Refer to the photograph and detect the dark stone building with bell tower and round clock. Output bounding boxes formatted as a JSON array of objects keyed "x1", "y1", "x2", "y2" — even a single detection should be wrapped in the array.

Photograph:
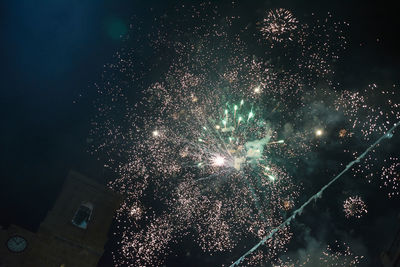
[{"x1": 0, "y1": 171, "x2": 121, "y2": 267}]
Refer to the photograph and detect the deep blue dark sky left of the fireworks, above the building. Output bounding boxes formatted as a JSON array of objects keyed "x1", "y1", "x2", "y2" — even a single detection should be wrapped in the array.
[{"x1": 0, "y1": 0, "x2": 156, "y2": 227}]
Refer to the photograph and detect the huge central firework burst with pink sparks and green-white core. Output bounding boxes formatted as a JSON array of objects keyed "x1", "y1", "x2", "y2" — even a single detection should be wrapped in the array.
[{"x1": 92, "y1": 4, "x2": 398, "y2": 266}]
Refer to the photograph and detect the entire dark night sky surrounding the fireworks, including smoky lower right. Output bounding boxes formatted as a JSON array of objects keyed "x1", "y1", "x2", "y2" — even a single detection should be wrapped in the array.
[{"x1": 0, "y1": 0, "x2": 400, "y2": 266}]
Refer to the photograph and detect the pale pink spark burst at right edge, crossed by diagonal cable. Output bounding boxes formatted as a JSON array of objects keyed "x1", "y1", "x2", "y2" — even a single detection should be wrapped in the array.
[{"x1": 335, "y1": 84, "x2": 400, "y2": 198}]
